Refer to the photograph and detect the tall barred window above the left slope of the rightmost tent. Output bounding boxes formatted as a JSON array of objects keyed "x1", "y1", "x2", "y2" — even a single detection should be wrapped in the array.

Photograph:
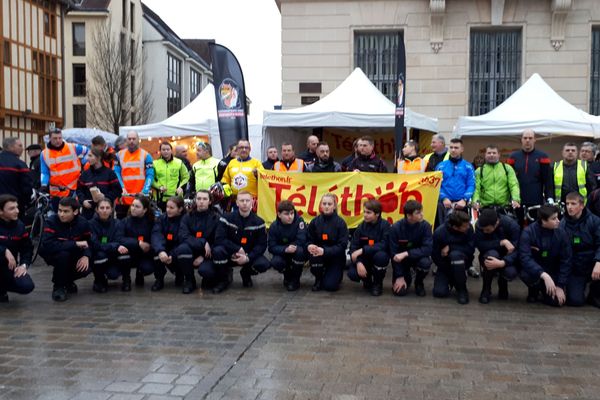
[{"x1": 469, "y1": 30, "x2": 521, "y2": 115}]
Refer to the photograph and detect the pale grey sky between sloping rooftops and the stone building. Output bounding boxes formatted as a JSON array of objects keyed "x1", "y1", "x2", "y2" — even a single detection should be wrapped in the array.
[{"x1": 144, "y1": 0, "x2": 281, "y2": 121}]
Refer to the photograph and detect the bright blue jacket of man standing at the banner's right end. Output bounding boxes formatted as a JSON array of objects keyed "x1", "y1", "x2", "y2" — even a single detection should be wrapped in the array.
[{"x1": 435, "y1": 158, "x2": 475, "y2": 201}]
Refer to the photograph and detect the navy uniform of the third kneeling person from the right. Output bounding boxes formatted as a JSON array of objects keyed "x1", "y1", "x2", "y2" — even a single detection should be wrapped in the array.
[{"x1": 475, "y1": 215, "x2": 521, "y2": 302}]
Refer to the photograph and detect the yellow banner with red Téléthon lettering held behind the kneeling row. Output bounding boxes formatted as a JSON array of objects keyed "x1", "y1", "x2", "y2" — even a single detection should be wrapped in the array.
[{"x1": 258, "y1": 171, "x2": 442, "y2": 228}]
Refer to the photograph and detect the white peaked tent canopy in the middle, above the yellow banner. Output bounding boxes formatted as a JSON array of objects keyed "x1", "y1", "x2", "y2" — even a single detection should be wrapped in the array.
[{"x1": 263, "y1": 68, "x2": 438, "y2": 151}]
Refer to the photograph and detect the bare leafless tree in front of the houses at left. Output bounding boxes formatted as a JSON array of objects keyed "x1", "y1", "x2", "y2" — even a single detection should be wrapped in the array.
[{"x1": 87, "y1": 20, "x2": 153, "y2": 134}]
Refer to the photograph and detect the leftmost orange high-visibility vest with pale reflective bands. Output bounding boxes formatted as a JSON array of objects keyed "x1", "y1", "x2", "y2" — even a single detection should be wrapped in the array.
[{"x1": 44, "y1": 143, "x2": 81, "y2": 197}]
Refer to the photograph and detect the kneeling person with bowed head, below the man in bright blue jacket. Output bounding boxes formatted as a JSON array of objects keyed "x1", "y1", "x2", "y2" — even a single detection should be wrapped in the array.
[{"x1": 431, "y1": 211, "x2": 475, "y2": 304}]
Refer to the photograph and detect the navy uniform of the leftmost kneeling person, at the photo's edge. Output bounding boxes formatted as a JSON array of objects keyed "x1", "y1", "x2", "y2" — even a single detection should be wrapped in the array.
[{"x1": 0, "y1": 219, "x2": 35, "y2": 300}]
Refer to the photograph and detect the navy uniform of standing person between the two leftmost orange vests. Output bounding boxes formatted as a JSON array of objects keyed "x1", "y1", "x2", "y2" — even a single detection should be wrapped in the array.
[{"x1": 77, "y1": 165, "x2": 123, "y2": 219}]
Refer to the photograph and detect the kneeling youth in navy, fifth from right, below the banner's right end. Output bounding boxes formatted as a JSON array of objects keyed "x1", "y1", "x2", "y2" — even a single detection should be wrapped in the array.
[{"x1": 389, "y1": 200, "x2": 433, "y2": 297}]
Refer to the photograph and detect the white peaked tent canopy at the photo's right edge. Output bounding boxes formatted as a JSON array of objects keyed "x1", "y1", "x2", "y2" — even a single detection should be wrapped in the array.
[{"x1": 454, "y1": 73, "x2": 600, "y2": 138}]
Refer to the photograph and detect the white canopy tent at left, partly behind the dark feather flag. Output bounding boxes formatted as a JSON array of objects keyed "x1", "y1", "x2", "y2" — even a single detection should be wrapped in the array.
[{"x1": 119, "y1": 83, "x2": 262, "y2": 159}]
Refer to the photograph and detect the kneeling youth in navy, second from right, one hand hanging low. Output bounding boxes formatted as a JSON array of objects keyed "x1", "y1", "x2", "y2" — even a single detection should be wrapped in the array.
[{"x1": 519, "y1": 204, "x2": 572, "y2": 306}]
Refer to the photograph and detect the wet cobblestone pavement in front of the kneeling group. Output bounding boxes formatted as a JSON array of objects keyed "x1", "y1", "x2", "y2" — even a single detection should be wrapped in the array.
[{"x1": 0, "y1": 266, "x2": 600, "y2": 400}]
